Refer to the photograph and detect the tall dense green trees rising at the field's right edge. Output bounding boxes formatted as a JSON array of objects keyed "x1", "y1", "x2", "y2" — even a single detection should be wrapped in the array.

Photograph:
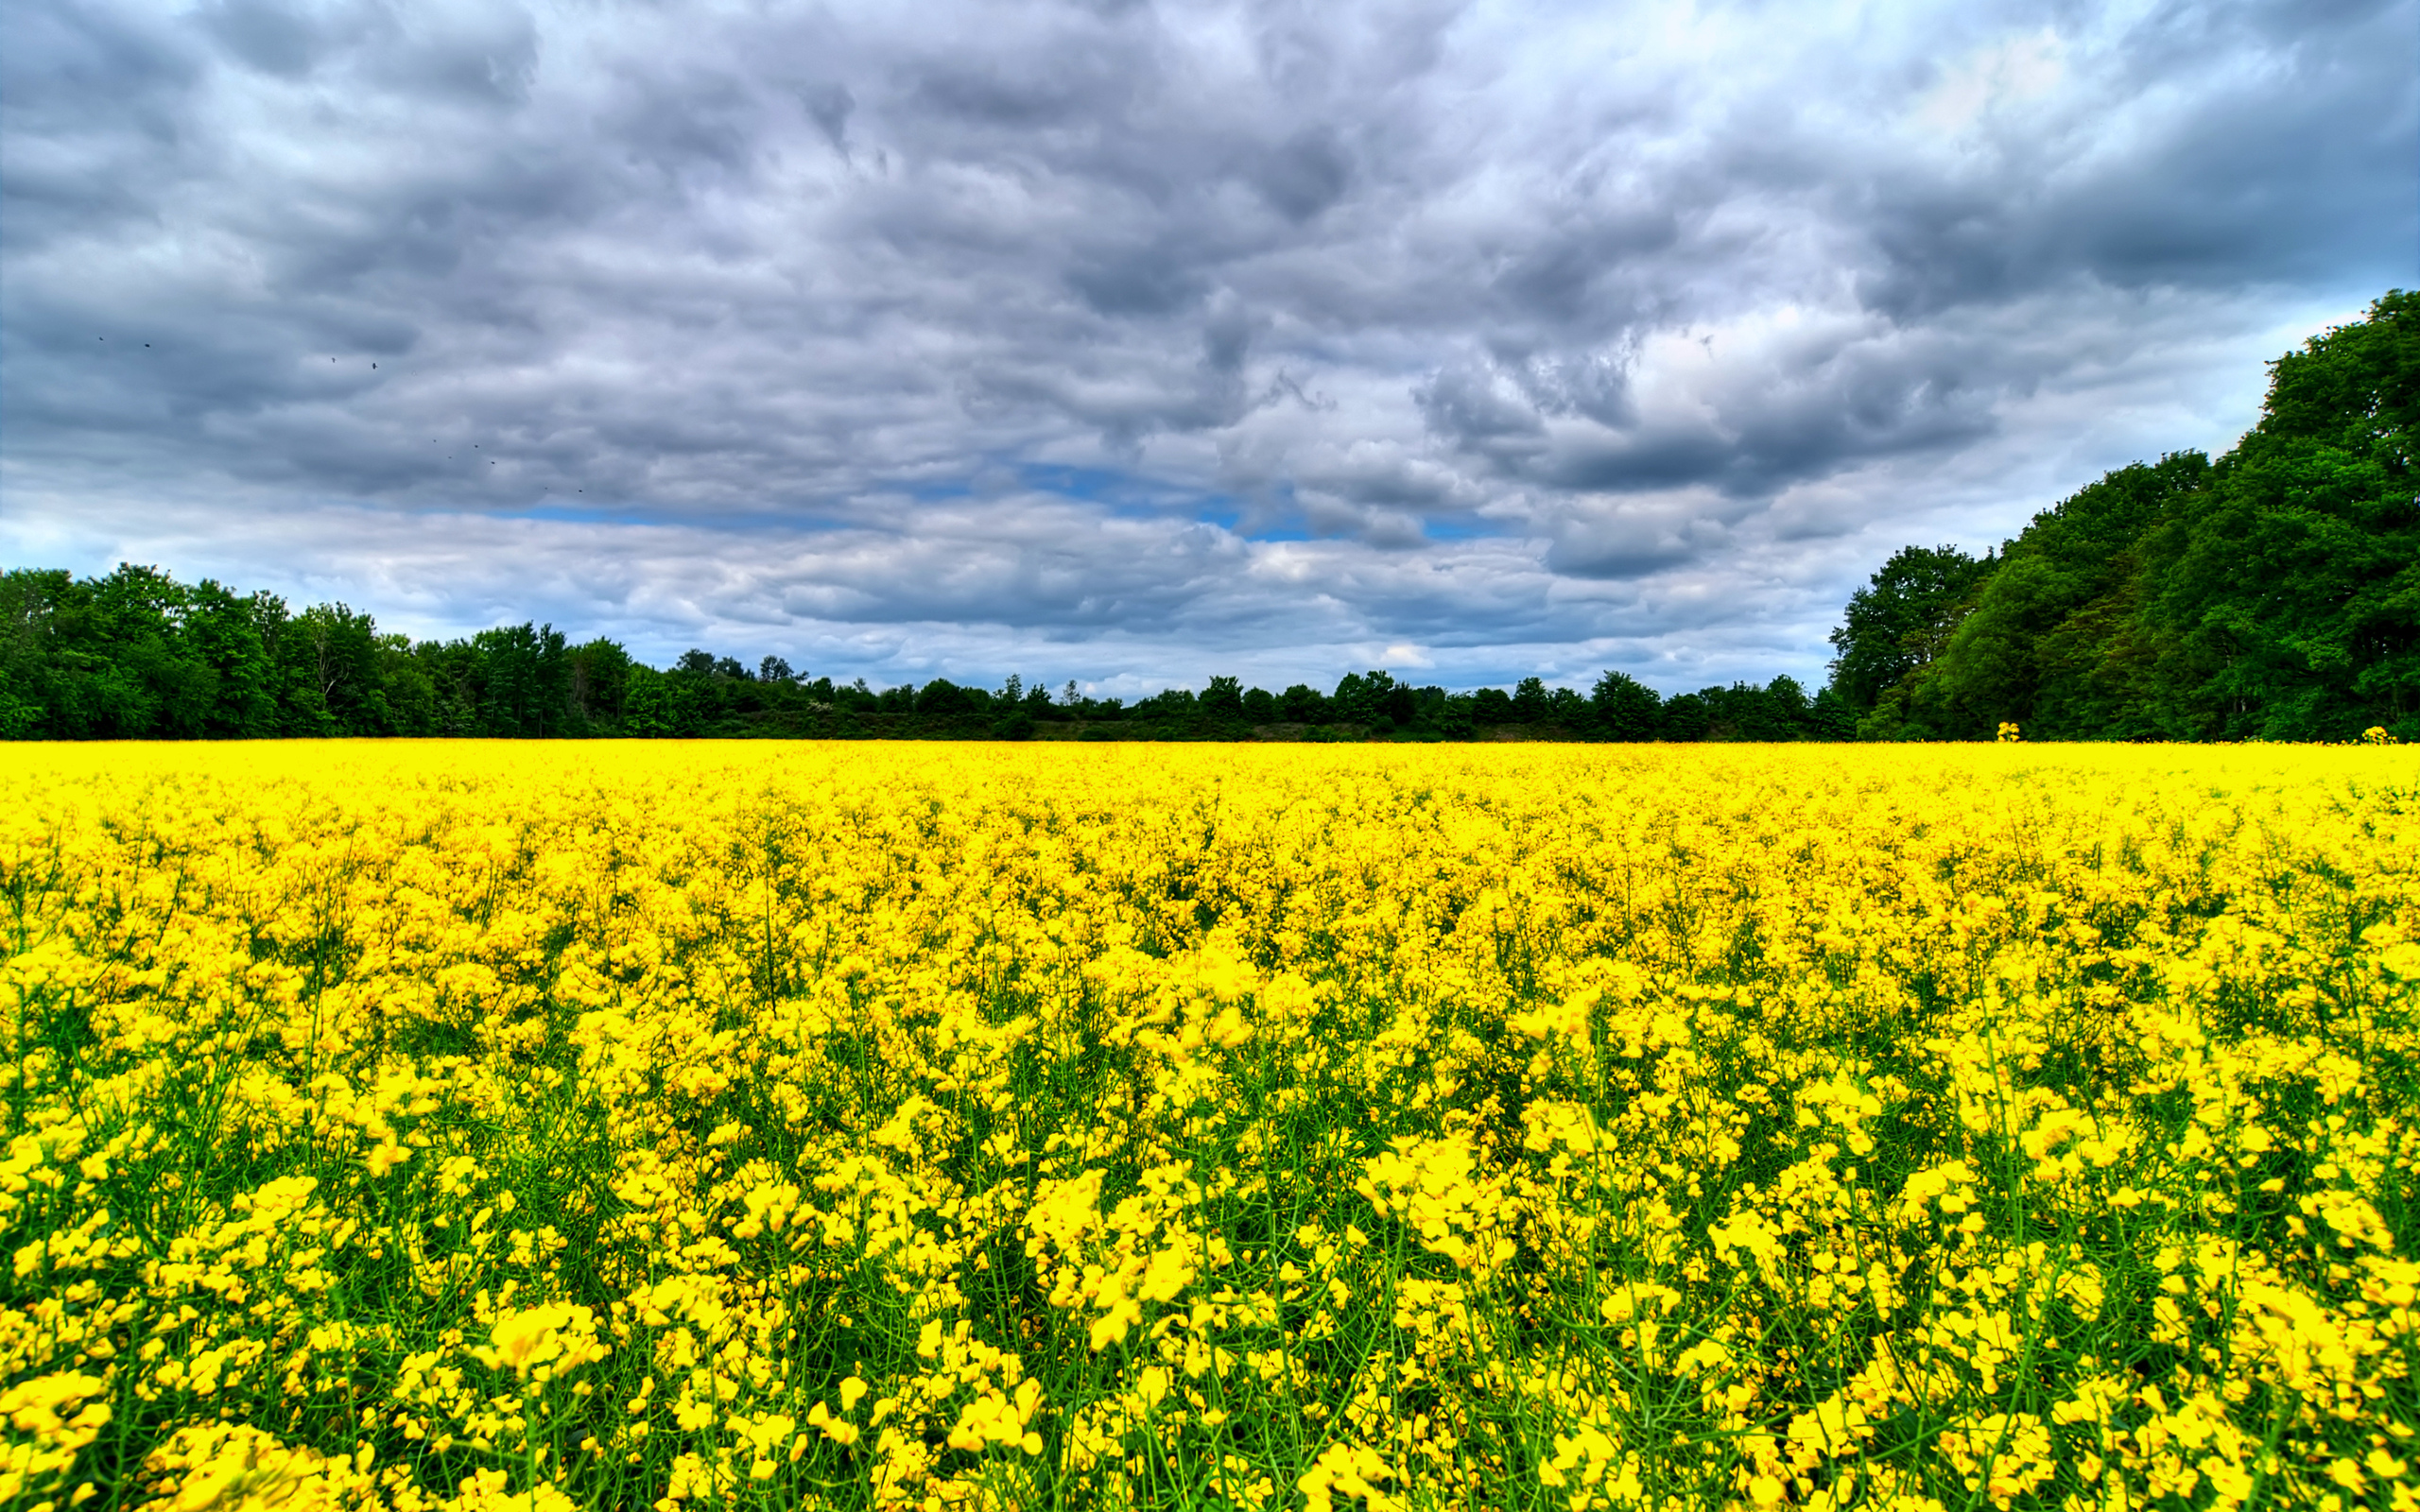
[{"x1": 1832, "y1": 290, "x2": 2420, "y2": 740}]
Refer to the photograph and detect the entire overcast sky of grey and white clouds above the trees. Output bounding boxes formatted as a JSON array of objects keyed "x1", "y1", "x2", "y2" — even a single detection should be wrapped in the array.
[{"x1": 0, "y1": 0, "x2": 2420, "y2": 692}]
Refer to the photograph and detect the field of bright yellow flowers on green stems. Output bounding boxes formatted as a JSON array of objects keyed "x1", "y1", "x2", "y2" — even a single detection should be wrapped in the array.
[{"x1": 0, "y1": 743, "x2": 2420, "y2": 1512}]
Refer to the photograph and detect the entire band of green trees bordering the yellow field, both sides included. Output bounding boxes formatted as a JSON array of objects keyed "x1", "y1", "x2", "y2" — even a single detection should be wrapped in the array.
[{"x1": 0, "y1": 290, "x2": 2420, "y2": 740}]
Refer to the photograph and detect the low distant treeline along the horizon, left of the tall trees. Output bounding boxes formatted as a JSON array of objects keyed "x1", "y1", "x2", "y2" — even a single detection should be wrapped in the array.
[{"x1": 0, "y1": 566, "x2": 1854, "y2": 740}]
